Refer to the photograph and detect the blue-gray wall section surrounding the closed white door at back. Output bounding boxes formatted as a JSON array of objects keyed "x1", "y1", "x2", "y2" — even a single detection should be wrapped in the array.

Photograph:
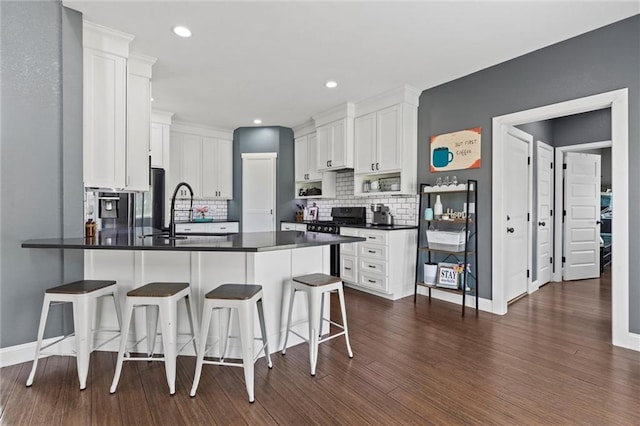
[{"x1": 227, "y1": 127, "x2": 296, "y2": 230}]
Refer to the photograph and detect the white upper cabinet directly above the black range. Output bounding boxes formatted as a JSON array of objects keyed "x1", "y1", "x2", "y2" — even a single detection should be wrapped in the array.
[{"x1": 314, "y1": 103, "x2": 354, "y2": 172}]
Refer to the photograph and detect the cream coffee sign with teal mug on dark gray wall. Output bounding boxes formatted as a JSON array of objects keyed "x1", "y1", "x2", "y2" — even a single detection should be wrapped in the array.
[{"x1": 431, "y1": 127, "x2": 482, "y2": 172}]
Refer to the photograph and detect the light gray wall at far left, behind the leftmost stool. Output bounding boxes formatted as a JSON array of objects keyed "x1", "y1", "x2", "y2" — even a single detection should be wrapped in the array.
[{"x1": 0, "y1": 1, "x2": 84, "y2": 348}]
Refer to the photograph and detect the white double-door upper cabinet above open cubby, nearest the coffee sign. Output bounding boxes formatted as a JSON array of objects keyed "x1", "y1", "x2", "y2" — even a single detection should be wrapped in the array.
[{"x1": 355, "y1": 105, "x2": 402, "y2": 173}]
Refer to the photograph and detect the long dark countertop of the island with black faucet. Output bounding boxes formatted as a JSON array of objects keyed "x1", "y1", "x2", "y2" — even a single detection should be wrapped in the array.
[{"x1": 22, "y1": 228, "x2": 365, "y2": 252}]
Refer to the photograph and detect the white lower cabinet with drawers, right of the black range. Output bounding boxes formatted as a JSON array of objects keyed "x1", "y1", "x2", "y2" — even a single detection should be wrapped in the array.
[{"x1": 340, "y1": 228, "x2": 417, "y2": 300}]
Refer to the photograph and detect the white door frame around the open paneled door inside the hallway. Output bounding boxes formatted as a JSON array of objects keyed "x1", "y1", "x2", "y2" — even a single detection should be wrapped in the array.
[{"x1": 551, "y1": 141, "x2": 612, "y2": 284}]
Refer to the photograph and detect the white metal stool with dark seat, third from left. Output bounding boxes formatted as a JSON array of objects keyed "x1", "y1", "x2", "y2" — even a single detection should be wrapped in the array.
[{"x1": 191, "y1": 284, "x2": 273, "y2": 402}]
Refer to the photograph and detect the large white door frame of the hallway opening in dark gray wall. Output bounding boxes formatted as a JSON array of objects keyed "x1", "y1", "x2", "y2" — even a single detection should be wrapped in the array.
[{"x1": 491, "y1": 88, "x2": 640, "y2": 351}]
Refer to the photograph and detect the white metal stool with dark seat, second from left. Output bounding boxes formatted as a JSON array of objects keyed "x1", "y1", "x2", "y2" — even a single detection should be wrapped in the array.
[{"x1": 110, "y1": 282, "x2": 197, "y2": 395}]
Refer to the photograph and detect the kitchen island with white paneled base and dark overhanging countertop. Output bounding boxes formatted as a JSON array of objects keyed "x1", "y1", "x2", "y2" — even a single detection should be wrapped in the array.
[{"x1": 22, "y1": 228, "x2": 364, "y2": 357}]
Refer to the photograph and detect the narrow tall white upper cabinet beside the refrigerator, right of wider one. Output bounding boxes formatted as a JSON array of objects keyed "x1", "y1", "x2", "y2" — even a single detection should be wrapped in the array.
[{"x1": 125, "y1": 54, "x2": 156, "y2": 191}]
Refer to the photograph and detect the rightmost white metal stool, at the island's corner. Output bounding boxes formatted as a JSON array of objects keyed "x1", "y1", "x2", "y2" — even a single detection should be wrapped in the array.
[{"x1": 282, "y1": 273, "x2": 353, "y2": 376}]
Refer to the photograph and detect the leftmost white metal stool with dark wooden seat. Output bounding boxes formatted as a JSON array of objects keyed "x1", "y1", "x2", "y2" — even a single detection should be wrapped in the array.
[{"x1": 27, "y1": 280, "x2": 121, "y2": 389}]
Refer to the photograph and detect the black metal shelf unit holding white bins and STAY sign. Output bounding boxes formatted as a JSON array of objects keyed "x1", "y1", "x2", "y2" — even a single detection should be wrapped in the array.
[{"x1": 413, "y1": 179, "x2": 479, "y2": 316}]
